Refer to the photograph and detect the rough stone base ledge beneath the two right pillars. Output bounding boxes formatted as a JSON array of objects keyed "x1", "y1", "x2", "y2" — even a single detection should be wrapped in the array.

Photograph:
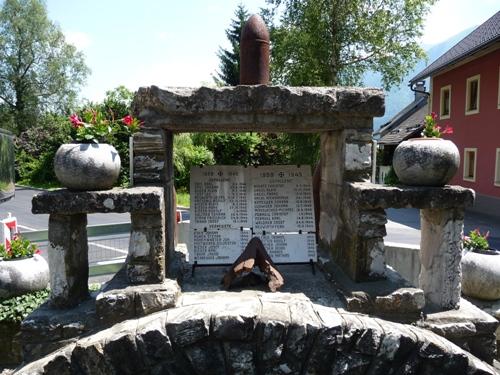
[{"x1": 320, "y1": 260, "x2": 499, "y2": 364}]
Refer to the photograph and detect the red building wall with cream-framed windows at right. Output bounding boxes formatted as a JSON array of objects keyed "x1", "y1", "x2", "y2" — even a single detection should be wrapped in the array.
[{"x1": 432, "y1": 49, "x2": 500, "y2": 198}]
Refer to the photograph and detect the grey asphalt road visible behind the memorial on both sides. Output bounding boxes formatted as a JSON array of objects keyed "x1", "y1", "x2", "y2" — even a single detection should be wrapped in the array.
[{"x1": 0, "y1": 188, "x2": 500, "y2": 249}]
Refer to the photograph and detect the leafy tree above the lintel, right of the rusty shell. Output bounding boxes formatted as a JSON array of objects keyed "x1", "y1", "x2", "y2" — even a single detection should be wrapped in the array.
[{"x1": 267, "y1": 0, "x2": 436, "y2": 88}]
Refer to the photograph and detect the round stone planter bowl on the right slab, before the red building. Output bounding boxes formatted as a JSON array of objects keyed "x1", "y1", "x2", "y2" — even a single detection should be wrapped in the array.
[{"x1": 392, "y1": 138, "x2": 460, "y2": 186}]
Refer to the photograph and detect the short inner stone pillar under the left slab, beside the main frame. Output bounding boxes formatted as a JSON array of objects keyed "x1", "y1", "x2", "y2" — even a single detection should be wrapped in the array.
[{"x1": 127, "y1": 211, "x2": 165, "y2": 284}]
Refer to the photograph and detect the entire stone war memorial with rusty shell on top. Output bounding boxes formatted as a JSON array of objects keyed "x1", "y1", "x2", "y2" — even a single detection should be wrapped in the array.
[{"x1": 9, "y1": 16, "x2": 498, "y2": 374}]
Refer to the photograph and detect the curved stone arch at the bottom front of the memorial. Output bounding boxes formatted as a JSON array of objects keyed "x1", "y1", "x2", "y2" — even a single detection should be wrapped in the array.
[{"x1": 14, "y1": 291, "x2": 496, "y2": 375}]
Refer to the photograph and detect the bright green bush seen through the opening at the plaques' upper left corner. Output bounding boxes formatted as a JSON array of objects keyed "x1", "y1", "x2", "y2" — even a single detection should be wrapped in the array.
[{"x1": 174, "y1": 133, "x2": 215, "y2": 191}]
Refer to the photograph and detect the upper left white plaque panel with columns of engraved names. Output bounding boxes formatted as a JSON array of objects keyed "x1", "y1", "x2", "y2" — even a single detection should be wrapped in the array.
[{"x1": 190, "y1": 165, "x2": 252, "y2": 229}]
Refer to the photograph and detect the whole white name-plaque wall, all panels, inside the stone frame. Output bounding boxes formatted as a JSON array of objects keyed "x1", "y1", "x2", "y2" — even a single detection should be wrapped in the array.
[{"x1": 189, "y1": 165, "x2": 317, "y2": 264}]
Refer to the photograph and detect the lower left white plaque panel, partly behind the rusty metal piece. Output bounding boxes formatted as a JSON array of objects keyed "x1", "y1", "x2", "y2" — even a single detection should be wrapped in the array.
[{"x1": 189, "y1": 229, "x2": 252, "y2": 264}]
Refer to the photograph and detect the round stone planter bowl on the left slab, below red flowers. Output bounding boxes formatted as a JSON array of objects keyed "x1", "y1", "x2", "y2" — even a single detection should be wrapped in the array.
[{"x1": 54, "y1": 143, "x2": 121, "y2": 190}]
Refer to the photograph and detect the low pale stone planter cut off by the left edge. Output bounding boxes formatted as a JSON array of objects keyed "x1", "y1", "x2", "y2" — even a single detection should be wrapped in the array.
[{"x1": 0, "y1": 254, "x2": 49, "y2": 298}]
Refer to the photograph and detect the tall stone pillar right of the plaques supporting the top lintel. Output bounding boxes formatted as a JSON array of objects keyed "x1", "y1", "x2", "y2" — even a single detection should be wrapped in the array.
[{"x1": 319, "y1": 128, "x2": 376, "y2": 281}]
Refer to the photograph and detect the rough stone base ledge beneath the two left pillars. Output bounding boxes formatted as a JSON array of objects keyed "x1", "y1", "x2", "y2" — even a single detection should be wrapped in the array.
[{"x1": 21, "y1": 270, "x2": 180, "y2": 361}]
